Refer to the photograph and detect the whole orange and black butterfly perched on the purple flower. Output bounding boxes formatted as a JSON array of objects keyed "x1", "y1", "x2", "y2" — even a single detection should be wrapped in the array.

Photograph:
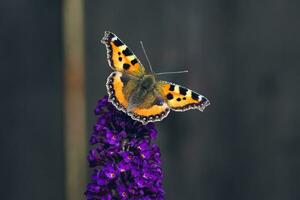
[{"x1": 101, "y1": 31, "x2": 210, "y2": 124}]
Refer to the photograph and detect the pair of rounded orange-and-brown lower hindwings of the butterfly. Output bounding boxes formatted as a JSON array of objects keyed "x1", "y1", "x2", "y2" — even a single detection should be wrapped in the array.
[{"x1": 106, "y1": 71, "x2": 170, "y2": 124}]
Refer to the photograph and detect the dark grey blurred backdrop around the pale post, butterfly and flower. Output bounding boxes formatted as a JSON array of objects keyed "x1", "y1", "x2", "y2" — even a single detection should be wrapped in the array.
[{"x1": 0, "y1": 0, "x2": 300, "y2": 200}]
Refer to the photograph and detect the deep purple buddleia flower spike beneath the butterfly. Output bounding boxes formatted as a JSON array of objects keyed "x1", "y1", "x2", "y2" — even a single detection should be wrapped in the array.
[{"x1": 85, "y1": 97, "x2": 164, "y2": 200}]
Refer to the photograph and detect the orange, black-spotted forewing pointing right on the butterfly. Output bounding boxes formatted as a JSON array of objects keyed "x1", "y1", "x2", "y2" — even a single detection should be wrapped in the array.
[{"x1": 156, "y1": 81, "x2": 210, "y2": 111}]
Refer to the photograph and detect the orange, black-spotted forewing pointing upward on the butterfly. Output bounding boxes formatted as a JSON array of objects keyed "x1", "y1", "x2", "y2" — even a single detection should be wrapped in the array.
[{"x1": 101, "y1": 31, "x2": 145, "y2": 77}]
